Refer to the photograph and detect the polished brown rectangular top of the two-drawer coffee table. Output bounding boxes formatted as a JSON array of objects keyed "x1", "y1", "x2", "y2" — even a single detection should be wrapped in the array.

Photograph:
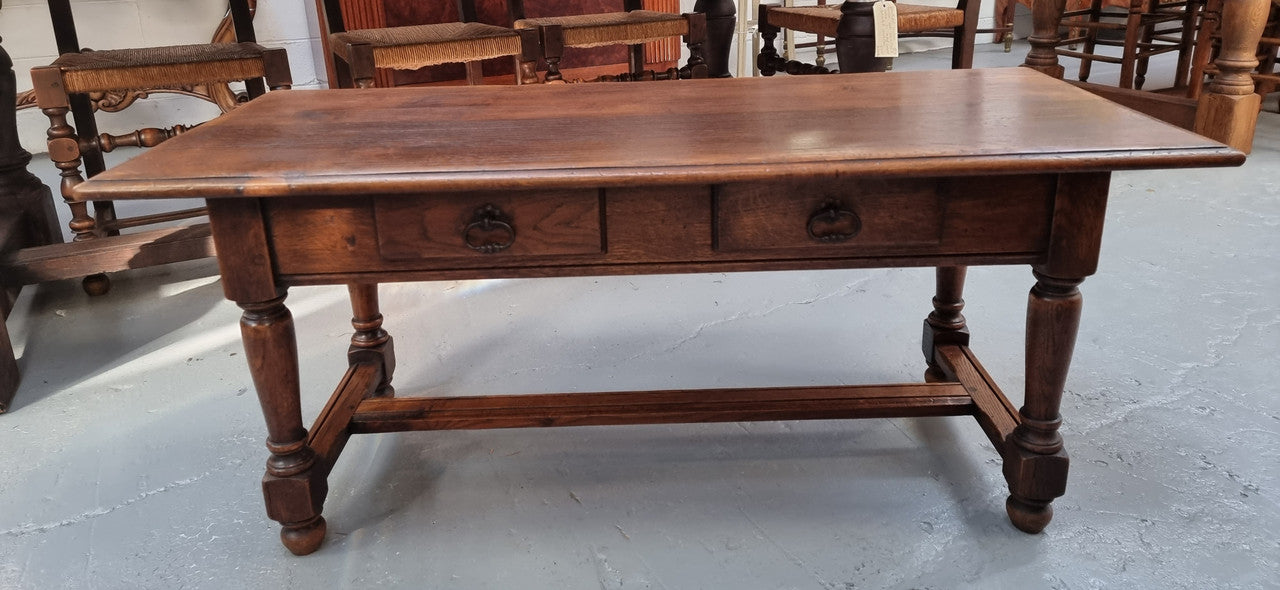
[{"x1": 74, "y1": 68, "x2": 1244, "y2": 200}]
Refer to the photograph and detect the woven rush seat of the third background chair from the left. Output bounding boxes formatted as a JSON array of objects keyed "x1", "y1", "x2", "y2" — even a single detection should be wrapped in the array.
[{"x1": 515, "y1": 10, "x2": 689, "y2": 47}]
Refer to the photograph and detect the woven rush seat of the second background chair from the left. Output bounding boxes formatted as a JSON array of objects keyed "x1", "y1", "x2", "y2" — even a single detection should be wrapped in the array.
[{"x1": 329, "y1": 23, "x2": 521, "y2": 69}]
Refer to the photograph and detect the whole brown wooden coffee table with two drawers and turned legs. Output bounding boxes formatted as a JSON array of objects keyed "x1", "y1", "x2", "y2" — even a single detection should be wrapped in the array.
[{"x1": 74, "y1": 69, "x2": 1244, "y2": 554}]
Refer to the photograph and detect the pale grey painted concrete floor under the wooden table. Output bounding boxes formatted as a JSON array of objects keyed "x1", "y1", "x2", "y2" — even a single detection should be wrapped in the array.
[{"x1": 0, "y1": 46, "x2": 1280, "y2": 590}]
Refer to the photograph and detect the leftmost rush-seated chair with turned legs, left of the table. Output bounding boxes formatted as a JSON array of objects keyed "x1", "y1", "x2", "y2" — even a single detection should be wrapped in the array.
[{"x1": 31, "y1": 0, "x2": 292, "y2": 294}]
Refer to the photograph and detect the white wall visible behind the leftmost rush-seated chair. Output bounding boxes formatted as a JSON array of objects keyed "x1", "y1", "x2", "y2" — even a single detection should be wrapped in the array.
[{"x1": 0, "y1": 0, "x2": 324, "y2": 154}]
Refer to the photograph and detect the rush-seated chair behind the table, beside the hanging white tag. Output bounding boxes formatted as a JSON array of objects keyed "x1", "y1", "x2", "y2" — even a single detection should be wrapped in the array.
[{"x1": 756, "y1": 0, "x2": 979, "y2": 76}]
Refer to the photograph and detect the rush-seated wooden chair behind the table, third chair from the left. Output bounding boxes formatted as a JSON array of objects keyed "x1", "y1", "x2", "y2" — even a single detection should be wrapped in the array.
[{"x1": 507, "y1": 0, "x2": 707, "y2": 82}]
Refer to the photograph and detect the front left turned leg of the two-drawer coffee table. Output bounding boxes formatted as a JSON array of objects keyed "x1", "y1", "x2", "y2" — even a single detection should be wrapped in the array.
[{"x1": 239, "y1": 294, "x2": 329, "y2": 555}]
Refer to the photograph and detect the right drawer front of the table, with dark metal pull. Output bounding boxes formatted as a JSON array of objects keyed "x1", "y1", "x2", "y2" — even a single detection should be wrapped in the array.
[{"x1": 714, "y1": 179, "x2": 943, "y2": 252}]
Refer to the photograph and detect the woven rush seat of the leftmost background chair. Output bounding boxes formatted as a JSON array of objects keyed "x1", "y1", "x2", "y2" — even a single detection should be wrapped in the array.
[{"x1": 51, "y1": 44, "x2": 277, "y2": 93}]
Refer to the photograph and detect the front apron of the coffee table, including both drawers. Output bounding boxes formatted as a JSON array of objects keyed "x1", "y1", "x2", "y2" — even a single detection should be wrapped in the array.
[{"x1": 252, "y1": 174, "x2": 1069, "y2": 284}]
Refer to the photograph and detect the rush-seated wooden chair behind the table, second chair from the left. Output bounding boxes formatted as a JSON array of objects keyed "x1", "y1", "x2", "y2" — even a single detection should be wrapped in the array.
[{"x1": 325, "y1": 0, "x2": 541, "y2": 88}]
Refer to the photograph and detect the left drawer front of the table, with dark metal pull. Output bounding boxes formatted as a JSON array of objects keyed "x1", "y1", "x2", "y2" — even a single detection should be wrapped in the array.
[{"x1": 374, "y1": 189, "x2": 604, "y2": 262}]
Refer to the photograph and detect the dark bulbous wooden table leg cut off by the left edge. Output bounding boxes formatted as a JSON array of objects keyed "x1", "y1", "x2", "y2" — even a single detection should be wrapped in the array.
[{"x1": 0, "y1": 35, "x2": 61, "y2": 412}]
